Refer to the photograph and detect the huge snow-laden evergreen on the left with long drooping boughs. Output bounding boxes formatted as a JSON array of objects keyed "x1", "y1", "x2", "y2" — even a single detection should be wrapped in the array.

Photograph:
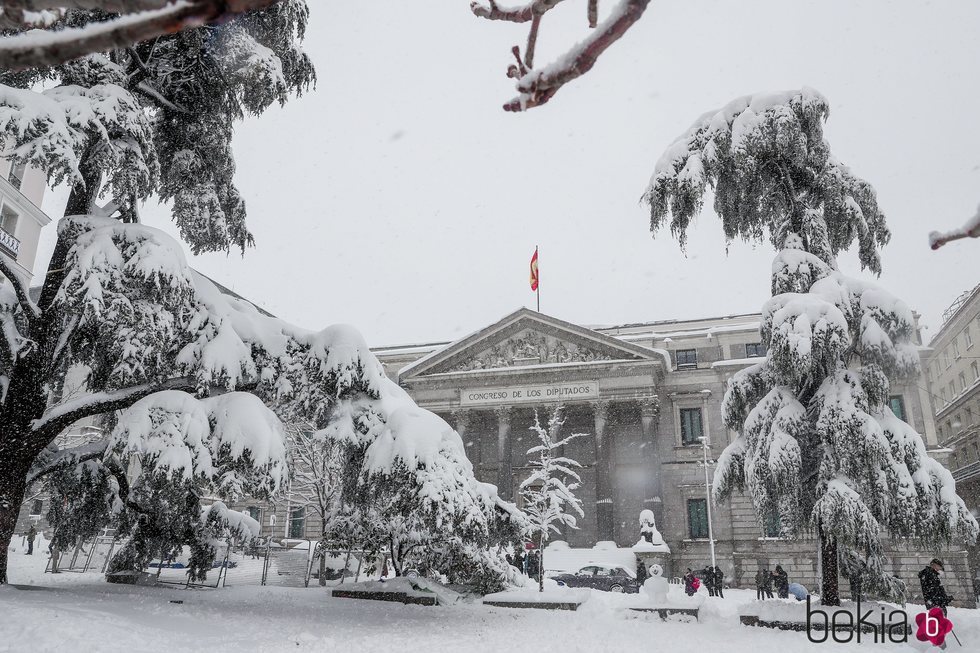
[{"x1": 0, "y1": 0, "x2": 521, "y2": 582}]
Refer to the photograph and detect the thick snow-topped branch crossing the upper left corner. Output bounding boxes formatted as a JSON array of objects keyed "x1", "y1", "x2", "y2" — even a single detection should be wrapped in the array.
[{"x1": 0, "y1": 0, "x2": 285, "y2": 71}]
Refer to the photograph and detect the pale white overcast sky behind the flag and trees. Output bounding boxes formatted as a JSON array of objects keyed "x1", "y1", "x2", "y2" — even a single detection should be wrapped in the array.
[{"x1": 38, "y1": 0, "x2": 980, "y2": 345}]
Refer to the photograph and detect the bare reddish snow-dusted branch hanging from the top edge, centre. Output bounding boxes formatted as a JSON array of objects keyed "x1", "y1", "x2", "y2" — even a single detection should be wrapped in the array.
[{"x1": 470, "y1": 0, "x2": 650, "y2": 111}]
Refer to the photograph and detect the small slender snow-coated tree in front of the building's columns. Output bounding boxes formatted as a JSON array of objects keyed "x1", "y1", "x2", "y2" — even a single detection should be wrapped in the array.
[{"x1": 520, "y1": 406, "x2": 587, "y2": 592}]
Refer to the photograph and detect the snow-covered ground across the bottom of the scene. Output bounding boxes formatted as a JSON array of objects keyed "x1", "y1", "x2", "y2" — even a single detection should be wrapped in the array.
[{"x1": 0, "y1": 554, "x2": 980, "y2": 653}]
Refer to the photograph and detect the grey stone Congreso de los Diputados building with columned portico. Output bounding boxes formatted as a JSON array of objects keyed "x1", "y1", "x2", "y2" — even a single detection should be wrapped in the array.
[{"x1": 250, "y1": 308, "x2": 974, "y2": 605}]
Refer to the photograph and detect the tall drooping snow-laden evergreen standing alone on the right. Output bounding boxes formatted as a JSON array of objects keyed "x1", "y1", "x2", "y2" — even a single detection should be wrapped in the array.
[{"x1": 645, "y1": 89, "x2": 977, "y2": 605}]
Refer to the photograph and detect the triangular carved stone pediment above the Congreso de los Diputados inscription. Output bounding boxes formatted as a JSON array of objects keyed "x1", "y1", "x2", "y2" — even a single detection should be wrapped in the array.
[{"x1": 399, "y1": 308, "x2": 658, "y2": 380}]
